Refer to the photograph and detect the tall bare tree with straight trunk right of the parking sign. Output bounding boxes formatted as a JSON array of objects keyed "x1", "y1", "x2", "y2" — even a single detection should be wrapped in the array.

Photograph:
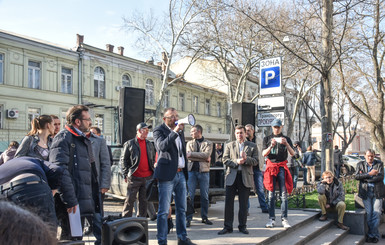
[{"x1": 230, "y1": 0, "x2": 355, "y2": 170}]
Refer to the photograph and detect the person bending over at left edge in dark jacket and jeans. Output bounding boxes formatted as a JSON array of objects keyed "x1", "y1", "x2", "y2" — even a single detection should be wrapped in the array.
[{"x1": 0, "y1": 157, "x2": 78, "y2": 233}]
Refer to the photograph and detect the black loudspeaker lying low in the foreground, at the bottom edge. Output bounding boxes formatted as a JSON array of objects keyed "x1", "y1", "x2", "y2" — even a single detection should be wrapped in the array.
[{"x1": 102, "y1": 217, "x2": 148, "y2": 245}]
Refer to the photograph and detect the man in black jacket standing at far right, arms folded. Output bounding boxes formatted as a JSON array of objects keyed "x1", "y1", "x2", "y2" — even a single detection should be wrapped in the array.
[{"x1": 355, "y1": 149, "x2": 385, "y2": 243}]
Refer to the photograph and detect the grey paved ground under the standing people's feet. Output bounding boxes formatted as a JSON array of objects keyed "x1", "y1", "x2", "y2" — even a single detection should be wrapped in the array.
[{"x1": 83, "y1": 196, "x2": 316, "y2": 245}]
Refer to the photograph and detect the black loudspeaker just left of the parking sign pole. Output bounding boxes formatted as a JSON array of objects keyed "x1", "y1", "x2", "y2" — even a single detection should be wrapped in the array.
[{"x1": 231, "y1": 103, "x2": 255, "y2": 140}]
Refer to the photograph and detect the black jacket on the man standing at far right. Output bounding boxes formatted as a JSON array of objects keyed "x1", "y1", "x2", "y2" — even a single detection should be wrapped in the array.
[{"x1": 355, "y1": 160, "x2": 385, "y2": 199}]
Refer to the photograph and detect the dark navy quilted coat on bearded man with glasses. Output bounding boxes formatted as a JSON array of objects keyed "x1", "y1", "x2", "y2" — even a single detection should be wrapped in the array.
[{"x1": 49, "y1": 125, "x2": 99, "y2": 215}]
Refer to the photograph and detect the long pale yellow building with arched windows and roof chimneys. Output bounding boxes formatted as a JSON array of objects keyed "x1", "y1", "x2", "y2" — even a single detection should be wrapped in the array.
[{"x1": 0, "y1": 30, "x2": 227, "y2": 151}]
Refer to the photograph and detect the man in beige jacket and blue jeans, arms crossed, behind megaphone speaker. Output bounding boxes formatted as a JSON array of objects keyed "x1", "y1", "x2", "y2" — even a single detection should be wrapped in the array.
[{"x1": 186, "y1": 125, "x2": 213, "y2": 227}]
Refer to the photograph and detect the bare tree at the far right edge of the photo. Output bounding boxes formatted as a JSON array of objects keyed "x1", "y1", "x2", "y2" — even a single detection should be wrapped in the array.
[{"x1": 339, "y1": 0, "x2": 385, "y2": 159}]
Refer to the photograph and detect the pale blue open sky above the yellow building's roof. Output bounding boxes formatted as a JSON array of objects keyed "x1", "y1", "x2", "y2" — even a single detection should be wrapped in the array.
[{"x1": 0, "y1": 0, "x2": 164, "y2": 60}]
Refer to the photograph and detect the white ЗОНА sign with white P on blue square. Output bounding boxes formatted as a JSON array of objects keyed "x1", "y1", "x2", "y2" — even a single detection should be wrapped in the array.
[{"x1": 259, "y1": 57, "x2": 282, "y2": 95}]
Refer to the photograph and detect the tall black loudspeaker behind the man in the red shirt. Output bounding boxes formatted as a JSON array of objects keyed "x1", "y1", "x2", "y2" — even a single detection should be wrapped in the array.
[{"x1": 119, "y1": 87, "x2": 146, "y2": 145}]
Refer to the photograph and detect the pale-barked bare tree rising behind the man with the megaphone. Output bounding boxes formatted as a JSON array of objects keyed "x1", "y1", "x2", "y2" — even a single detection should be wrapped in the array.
[{"x1": 123, "y1": 0, "x2": 204, "y2": 125}]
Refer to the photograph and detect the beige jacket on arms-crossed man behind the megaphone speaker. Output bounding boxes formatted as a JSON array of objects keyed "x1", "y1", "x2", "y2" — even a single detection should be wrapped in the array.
[{"x1": 186, "y1": 139, "x2": 213, "y2": 173}]
